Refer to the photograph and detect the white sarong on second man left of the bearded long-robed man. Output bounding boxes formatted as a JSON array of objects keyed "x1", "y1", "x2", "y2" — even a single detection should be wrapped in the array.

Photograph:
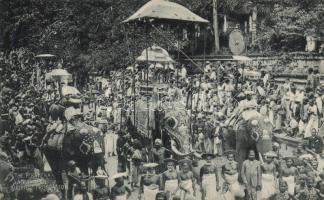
[{"x1": 202, "y1": 174, "x2": 221, "y2": 200}]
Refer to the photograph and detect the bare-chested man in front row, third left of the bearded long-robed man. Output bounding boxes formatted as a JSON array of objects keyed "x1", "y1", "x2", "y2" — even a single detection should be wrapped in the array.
[{"x1": 178, "y1": 159, "x2": 196, "y2": 200}]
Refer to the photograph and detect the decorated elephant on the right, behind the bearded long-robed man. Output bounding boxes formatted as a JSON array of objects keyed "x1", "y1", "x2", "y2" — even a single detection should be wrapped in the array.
[{"x1": 222, "y1": 110, "x2": 273, "y2": 174}]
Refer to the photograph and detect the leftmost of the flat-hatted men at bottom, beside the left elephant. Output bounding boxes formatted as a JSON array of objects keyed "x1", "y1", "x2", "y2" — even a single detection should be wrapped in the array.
[{"x1": 92, "y1": 175, "x2": 110, "y2": 200}]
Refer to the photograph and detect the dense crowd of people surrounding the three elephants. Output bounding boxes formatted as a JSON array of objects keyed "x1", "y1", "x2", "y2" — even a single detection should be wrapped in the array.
[{"x1": 0, "y1": 47, "x2": 324, "y2": 200}]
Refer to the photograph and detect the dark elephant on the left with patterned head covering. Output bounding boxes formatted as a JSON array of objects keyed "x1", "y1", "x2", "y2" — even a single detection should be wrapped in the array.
[{"x1": 42, "y1": 105, "x2": 105, "y2": 198}]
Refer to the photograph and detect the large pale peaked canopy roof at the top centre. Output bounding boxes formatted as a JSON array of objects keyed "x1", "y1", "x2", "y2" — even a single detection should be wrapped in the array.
[{"x1": 123, "y1": 0, "x2": 208, "y2": 23}]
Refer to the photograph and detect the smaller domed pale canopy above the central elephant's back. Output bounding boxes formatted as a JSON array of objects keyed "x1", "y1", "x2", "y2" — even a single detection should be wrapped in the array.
[{"x1": 136, "y1": 45, "x2": 175, "y2": 63}]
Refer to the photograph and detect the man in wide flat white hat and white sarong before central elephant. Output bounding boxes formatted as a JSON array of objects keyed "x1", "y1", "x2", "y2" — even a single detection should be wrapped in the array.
[{"x1": 139, "y1": 163, "x2": 161, "y2": 200}]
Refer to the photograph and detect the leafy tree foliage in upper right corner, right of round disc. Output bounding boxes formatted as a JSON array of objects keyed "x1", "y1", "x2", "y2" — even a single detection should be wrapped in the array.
[{"x1": 255, "y1": 0, "x2": 324, "y2": 52}]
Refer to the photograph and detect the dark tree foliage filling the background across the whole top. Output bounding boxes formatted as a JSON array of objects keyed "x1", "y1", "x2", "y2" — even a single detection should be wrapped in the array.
[{"x1": 0, "y1": 0, "x2": 324, "y2": 75}]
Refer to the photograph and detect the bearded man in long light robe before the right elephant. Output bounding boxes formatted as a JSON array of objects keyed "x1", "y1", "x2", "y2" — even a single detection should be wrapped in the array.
[{"x1": 241, "y1": 150, "x2": 262, "y2": 200}]
